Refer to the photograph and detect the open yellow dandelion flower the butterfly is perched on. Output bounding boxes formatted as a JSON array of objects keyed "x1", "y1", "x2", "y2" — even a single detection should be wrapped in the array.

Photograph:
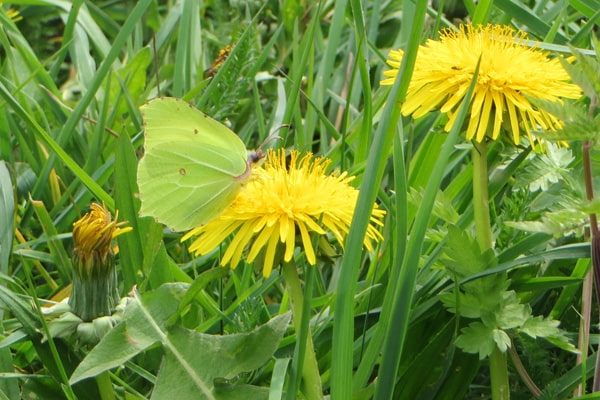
[{"x1": 182, "y1": 150, "x2": 385, "y2": 277}]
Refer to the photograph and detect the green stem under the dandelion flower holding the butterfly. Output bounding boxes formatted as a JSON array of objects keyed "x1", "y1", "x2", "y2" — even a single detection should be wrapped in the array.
[{"x1": 282, "y1": 262, "x2": 323, "y2": 400}]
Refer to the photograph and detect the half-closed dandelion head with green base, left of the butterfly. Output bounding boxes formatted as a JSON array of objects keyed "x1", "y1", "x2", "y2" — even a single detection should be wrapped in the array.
[{"x1": 69, "y1": 203, "x2": 132, "y2": 321}]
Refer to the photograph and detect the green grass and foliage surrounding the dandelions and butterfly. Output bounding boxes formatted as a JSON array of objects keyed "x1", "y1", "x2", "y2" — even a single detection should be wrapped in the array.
[{"x1": 0, "y1": 0, "x2": 600, "y2": 399}]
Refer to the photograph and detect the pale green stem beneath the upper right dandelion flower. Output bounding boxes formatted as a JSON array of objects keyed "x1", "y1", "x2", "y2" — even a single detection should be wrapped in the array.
[{"x1": 472, "y1": 141, "x2": 510, "y2": 400}]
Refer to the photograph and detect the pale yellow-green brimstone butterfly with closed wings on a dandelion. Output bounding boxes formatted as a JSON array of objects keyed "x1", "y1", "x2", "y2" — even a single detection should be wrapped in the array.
[{"x1": 137, "y1": 97, "x2": 262, "y2": 231}]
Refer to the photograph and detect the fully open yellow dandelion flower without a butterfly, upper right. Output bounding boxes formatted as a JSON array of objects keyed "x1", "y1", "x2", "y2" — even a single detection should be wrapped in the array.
[{"x1": 381, "y1": 25, "x2": 581, "y2": 144}]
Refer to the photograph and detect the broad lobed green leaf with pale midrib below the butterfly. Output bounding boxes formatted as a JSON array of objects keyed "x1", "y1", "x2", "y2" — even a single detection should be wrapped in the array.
[{"x1": 70, "y1": 284, "x2": 290, "y2": 399}]
